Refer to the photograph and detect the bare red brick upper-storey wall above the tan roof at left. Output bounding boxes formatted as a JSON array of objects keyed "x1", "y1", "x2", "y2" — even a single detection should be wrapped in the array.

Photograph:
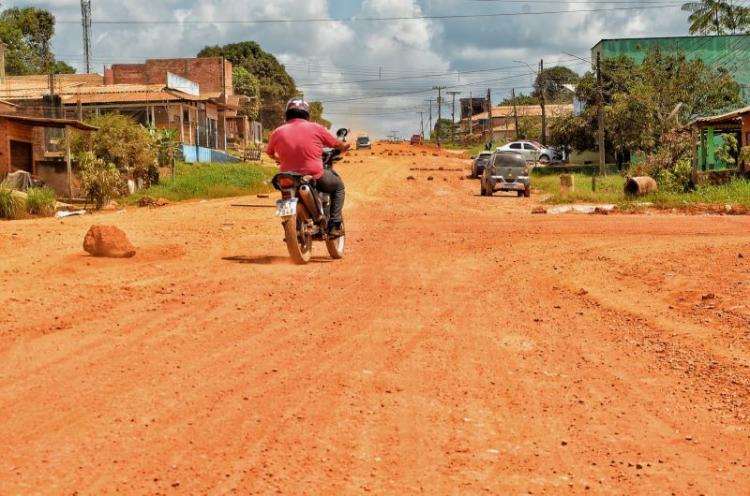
[{"x1": 112, "y1": 57, "x2": 233, "y2": 95}]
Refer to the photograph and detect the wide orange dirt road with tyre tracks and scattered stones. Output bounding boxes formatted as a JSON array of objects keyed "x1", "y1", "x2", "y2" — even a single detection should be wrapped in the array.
[{"x1": 0, "y1": 142, "x2": 750, "y2": 495}]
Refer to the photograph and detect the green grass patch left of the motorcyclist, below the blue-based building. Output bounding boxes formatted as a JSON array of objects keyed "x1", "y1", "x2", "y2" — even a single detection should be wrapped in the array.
[{"x1": 124, "y1": 163, "x2": 278, "y2": 204}]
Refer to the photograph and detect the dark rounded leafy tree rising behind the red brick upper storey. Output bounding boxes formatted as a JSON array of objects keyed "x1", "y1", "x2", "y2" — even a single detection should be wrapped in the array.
[{"x1": 198, "y1": 41, "x2": 297, "y2": 129}]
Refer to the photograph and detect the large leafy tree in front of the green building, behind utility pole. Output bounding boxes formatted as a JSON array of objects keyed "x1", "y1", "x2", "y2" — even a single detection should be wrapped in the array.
[{"x1": 550, "y1": 50, "x2": 742, "y2": 159}]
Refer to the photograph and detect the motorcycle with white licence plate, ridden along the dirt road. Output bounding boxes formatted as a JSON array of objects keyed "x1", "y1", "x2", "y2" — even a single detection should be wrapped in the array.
[{"x1": 271, "y1": 129, "x2": 349, "y2": 265}]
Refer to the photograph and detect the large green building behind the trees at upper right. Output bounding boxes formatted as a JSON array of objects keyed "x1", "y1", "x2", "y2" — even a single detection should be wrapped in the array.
[{"x1": 591, "y1": 34, "x2": 750, "y2": 103}]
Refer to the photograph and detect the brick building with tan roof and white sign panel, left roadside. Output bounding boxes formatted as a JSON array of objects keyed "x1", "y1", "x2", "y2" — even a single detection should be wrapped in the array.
[{"x1": 0, "y1": 57, "x2": 262, "y2": 162}]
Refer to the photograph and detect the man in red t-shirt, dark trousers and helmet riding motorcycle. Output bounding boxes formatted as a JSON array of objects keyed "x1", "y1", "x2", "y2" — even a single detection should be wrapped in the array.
[{"x1": 266, "y1": 98, "x2": 350, "y2": 237}]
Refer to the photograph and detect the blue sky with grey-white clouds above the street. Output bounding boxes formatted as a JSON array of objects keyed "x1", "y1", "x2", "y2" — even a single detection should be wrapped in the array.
[{"x1": 13, "y1": 0, "x2": 687, "y2": 136}]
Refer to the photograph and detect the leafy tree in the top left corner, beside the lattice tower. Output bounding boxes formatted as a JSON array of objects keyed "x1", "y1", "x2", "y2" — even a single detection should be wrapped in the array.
[{"x1": 0, "y1": 7, "x2": 75, "y2": 75}]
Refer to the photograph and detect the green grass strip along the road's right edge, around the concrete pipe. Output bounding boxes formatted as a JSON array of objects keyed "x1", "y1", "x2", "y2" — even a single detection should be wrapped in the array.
[{"x1": 531, "y1": 173, "x2": 750, "y2": 209}]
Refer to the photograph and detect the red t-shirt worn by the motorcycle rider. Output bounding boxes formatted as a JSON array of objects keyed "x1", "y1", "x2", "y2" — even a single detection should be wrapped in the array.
[{"x1": 268, "y1": 119, "x2": 336, "y2": 179}]
